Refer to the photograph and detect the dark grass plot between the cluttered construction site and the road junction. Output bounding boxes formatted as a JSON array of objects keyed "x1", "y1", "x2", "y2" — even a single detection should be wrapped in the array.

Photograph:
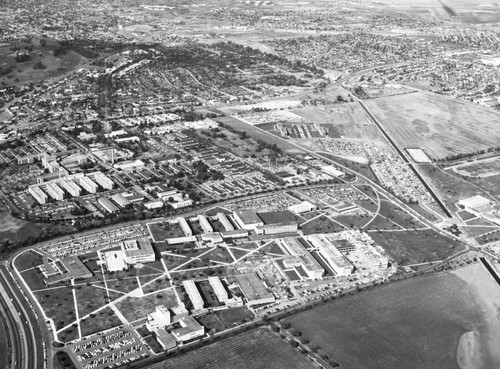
[{"x1": 369, "y1": 229, "x2": 463, "y2": 265}]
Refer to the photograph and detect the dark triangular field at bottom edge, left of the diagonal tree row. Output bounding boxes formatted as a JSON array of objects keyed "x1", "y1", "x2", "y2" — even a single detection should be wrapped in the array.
[{"x1": 156, "y1": 328, "x2": 314, "y2": 369}]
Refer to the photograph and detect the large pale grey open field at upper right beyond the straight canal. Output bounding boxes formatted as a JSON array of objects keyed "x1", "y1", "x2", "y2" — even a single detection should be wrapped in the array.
[{"x1": 365, "y1": 92, "x2": 500, "y2": 158}]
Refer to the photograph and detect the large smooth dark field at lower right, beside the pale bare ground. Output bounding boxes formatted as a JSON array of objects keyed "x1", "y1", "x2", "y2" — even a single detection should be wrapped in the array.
[{"x1": 287, "y1": 274, "x2": 490, "y2": 369}]
